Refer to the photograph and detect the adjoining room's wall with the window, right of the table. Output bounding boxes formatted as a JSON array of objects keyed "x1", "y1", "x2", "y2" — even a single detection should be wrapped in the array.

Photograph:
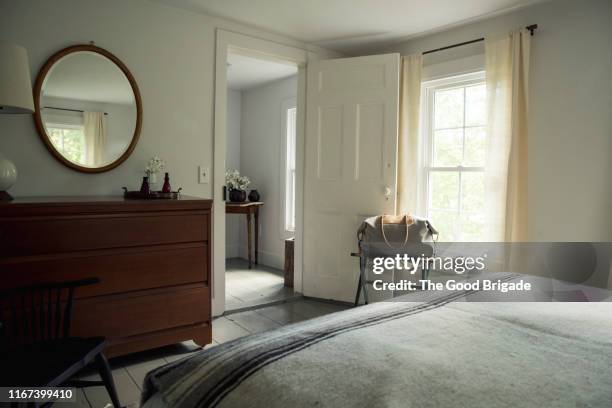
[{"x1": 240, "y1": 76, "x2": 297, "y2": 269}]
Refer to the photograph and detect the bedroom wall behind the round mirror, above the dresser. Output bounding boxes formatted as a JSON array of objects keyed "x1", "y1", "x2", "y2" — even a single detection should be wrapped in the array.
[{"x1": 0, "y1": 0, "x2": 334, "y2": 198}]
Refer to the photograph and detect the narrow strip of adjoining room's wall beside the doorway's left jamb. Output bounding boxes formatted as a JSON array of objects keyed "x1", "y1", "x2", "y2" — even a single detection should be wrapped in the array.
[{"x1": 225, "y1": 89, "x2": 246, "y2": 258}]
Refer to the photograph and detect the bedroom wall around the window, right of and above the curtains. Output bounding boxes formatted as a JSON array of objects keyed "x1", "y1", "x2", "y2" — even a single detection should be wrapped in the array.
[{"x1": 376, "y1": 0, "x2": 612, "y2": 241}]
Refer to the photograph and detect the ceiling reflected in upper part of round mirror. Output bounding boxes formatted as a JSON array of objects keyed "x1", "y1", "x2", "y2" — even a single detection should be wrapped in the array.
[{"x1": 43, "y1": 52, "x2": 134, "y2": 105}]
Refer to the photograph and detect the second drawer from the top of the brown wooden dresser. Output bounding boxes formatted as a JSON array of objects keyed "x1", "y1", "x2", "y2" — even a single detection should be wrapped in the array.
[{"x1": 0, "y1": 242, "x2": 209, "y2": 298}]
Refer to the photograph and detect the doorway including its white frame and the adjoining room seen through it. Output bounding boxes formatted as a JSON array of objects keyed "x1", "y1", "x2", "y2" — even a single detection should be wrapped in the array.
[{"x1": 212, "y1": 30, "x2": 308, "y2": 316}]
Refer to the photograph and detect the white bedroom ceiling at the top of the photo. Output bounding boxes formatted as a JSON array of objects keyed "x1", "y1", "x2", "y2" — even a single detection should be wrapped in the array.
[{"x1": 155, "y1": 0, "x2": 542, "y2": 54}]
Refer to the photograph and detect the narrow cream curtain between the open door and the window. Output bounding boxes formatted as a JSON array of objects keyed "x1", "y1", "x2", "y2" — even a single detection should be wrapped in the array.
[{"x1": 396, "y1": 54, "x2": 423, "y2": 214}]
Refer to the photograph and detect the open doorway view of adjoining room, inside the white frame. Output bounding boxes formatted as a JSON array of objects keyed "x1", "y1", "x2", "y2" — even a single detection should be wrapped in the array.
[{"x1": 225, "y1": 50, "x2": 298, "y2": 311}]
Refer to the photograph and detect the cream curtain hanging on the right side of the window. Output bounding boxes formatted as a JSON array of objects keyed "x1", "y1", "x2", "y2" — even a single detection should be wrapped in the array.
[{"x1": 485, "y1": 29, "x2": 531, "y2": 242}]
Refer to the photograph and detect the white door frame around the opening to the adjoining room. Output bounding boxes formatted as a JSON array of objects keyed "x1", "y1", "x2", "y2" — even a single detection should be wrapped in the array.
[{"x1": 211, "y1": 29, "x2": 313, "y2": 316}]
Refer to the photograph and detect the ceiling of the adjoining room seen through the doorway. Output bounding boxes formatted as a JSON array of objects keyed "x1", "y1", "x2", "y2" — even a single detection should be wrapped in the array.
[{"x1": 227, "y1": 53, "x2": 297, "y2": 91}]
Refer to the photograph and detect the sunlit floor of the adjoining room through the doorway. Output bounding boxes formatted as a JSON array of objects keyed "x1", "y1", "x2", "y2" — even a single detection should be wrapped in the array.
[{"x1": 225, "y1": 258, "x2": 295, "y2": 311}]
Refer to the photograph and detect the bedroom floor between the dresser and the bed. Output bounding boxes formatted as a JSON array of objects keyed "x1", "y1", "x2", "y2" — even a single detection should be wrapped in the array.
[{"x1": 64, "y1": 299, "x2": 347, "y2": 408}]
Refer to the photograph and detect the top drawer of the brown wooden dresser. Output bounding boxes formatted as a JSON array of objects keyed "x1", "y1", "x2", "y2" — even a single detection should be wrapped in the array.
[{"x1": 0, "y1": 212, "x2": 209, "y2": 256}]
